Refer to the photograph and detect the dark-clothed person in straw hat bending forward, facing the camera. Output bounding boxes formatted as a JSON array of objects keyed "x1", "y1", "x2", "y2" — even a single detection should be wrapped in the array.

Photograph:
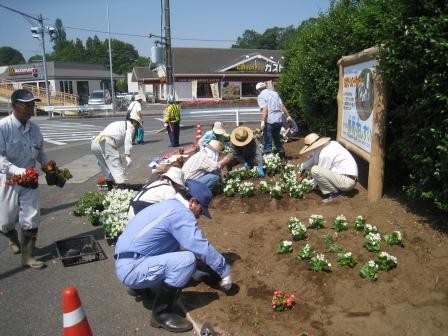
[{"x1": 228, "y1": 126, "x2": 265, "y2": 177}]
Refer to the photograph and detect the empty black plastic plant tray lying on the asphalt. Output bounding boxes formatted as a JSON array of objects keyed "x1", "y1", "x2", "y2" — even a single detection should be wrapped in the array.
[{"x1": 55, "y1": 235, "x2": 107, "y2": 266}]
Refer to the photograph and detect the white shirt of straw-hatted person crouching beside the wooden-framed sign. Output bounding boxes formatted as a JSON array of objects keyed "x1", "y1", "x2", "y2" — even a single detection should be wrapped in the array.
[{"x1": 310, "y1": 141, "x2": 358, "y2": 176}]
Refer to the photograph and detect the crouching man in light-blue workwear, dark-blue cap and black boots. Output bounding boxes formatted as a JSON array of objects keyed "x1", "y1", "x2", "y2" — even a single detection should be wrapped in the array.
[{"x1": 114, "y1": 181, "x2": 232, "y2": 332}]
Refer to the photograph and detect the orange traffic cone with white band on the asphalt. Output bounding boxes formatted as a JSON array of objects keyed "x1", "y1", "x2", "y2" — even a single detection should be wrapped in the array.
[{"x1": 62, "y1": 287, "x2": 93, "y2": 336}]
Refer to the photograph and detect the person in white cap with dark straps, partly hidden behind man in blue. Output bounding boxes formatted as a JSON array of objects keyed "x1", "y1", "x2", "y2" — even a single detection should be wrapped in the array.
[{"x1": 128, "y1": 167, "x2": 185, "y2": 220}]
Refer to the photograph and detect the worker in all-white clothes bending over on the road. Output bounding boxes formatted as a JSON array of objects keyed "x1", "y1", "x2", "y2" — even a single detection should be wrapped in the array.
[{"x1": 91, "y1": 114, "x2": 142, "y2": 190}]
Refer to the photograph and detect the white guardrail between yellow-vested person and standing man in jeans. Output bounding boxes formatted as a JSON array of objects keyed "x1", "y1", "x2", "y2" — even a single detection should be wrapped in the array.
[{"x1": 181, "y1": 107, "x2": 261, "y2": 126}]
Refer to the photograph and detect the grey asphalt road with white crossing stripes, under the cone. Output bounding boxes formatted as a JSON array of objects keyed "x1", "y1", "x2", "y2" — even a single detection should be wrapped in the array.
[{"x1": 0, "y1": 109, "x2": 260, "y2": 336}]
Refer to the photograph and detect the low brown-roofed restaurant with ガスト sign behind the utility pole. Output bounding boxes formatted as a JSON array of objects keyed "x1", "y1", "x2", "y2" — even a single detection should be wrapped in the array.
[{"x1": 132, "y1": 48, "x2": 283, "y2": 101}]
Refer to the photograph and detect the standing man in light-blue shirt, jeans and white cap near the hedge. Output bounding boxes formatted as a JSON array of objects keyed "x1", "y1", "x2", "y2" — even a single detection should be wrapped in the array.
[{"x1": 255, "y1": 82, "x2": 292, "y2": 158}]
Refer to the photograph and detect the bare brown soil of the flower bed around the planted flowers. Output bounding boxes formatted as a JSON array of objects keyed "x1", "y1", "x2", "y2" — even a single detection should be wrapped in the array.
[{"x1": 182, "y1": 141, "x2": 448, "y2": 336}]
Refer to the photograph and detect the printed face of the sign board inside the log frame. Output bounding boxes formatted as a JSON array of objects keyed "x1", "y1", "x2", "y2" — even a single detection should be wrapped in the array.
[{"x1": 341, "y1": 60, "x2": 377, "y2": 153}]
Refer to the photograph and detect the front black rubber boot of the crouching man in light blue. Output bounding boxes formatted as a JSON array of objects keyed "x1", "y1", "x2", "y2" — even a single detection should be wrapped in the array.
[{"x1": 151, "y1": 282, "x2": 193, "y2": 332}]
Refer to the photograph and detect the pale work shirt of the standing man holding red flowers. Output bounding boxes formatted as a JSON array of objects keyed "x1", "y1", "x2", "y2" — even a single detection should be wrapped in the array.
[{"x1": 0, "y1": 114, "x2": 48, "y2": 175}]
